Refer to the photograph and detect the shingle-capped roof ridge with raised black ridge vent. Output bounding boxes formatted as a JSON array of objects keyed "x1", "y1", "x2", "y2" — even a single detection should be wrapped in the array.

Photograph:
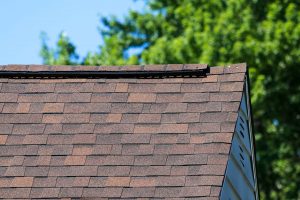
[{"x1": 0, "y1": 63, "x2": 246, "y2": 78}]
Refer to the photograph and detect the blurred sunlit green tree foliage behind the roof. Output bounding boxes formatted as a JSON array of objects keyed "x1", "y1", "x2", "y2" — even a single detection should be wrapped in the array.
[{"x1": 41, "y1": 0, "x2": 300, "y2": 199}]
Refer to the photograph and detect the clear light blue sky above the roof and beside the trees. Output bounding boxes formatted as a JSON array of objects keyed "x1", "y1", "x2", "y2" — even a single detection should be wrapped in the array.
[{"x1": 0, "y1": 0, "x2": 144, "y2": 65}]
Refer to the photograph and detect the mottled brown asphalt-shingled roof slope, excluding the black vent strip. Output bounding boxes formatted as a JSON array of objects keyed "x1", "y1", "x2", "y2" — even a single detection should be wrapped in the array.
[{"x1": 0, "y1": 64, "x2": 246, "y2": 199}]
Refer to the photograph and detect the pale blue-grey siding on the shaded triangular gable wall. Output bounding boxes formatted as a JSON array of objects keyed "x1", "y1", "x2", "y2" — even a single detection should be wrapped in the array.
[{"x1": 220, "y1": 80, "x2": 258, "y2": 200}]
